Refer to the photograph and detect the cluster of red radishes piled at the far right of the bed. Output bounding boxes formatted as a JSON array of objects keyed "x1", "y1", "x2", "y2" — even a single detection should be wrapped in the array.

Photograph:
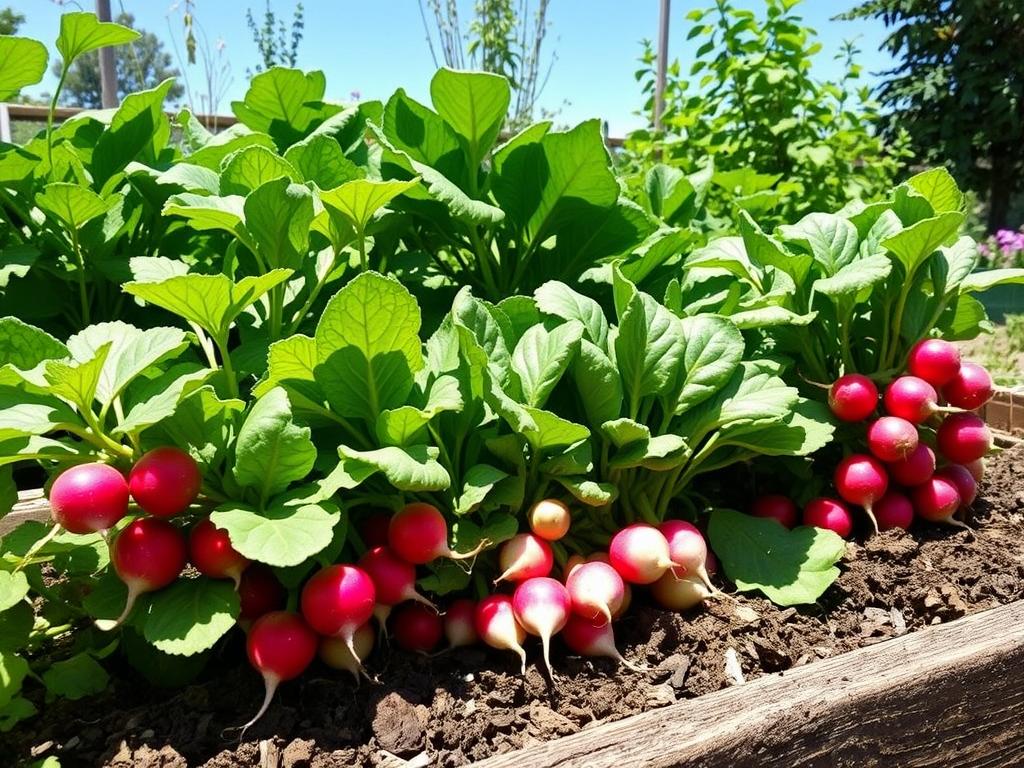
[{"x1": 753, "y1": 339, "x2": 993, "y2": 538}]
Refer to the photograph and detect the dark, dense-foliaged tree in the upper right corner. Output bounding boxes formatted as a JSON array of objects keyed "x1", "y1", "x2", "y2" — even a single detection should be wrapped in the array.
[{"x1": 845, "y1": 0, "x2": 1024, "y2": 231}]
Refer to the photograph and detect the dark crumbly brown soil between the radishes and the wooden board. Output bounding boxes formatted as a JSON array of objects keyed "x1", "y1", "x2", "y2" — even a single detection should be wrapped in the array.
[{"x1": 8, "y1": 446, "x2": 1024, "y2": 768}]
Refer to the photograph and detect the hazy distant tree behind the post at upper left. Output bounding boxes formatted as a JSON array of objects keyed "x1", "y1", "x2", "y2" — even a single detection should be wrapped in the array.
[{"x1": 53, "y1": 13, "x2": 184, "y2": 109}]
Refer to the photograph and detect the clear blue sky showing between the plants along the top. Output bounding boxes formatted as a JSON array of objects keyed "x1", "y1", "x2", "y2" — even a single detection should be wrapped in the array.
[{"x1": 9, "y1": 0, "x2": 890, "y2": 136}]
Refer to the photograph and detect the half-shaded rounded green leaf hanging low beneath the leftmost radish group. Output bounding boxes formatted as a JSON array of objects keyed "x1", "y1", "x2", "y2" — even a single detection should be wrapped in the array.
[{"x1": 142, "y1": 581, "x2": 240, "y2": 656}]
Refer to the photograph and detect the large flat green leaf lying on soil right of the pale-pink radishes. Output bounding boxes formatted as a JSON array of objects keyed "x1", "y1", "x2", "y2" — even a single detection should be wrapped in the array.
[{"x1": 708, "y1": 509, "x2": 846, "y2": 605}]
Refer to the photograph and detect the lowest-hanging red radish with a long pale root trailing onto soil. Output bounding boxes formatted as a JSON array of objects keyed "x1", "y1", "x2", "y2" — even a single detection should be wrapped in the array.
[{"x1": 242, "y1": 610, "x2": 316, "y2": 734}]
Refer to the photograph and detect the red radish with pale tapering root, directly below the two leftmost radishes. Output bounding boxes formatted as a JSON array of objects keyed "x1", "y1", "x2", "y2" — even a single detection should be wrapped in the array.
[{"x1": 96, "y1": 517, "x2": 186, "y2": 631}]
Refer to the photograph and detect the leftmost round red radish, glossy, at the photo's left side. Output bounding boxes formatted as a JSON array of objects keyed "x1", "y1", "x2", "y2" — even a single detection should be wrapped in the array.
[{"x1": 49, "y1": 462, "x2": 128, "y2": 534}]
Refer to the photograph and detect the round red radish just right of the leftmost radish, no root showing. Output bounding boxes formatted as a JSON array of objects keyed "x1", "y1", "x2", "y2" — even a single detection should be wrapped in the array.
[{"x1": 128, "y1": 445, "x2": 203, "y2": 517}]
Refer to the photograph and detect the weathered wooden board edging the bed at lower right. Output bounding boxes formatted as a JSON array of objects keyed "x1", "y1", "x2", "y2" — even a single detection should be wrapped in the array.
[{"x1": 475, "y1": 601, "x2": 1024, "y2": 768}]
